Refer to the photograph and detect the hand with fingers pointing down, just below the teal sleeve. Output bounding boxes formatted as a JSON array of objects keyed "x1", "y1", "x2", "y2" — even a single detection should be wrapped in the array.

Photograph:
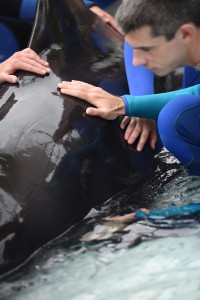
[{"x1": 120, "y1": 117, "x2": 157, "y2": 151}]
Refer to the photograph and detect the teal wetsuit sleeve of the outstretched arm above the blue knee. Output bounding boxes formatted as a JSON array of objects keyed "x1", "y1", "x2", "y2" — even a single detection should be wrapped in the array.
[{"x1": 122, "y1": 84, "x2": 200, "y2": 119}]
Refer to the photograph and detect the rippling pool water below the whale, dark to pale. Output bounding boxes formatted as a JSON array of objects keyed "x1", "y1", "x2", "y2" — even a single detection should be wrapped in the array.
[{"x1": 0, "y1": 151, "x2": 200, "y2": 300}]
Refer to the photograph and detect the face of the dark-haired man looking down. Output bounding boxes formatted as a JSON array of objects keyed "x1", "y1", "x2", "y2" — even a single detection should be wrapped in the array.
[{"x1": 125, "y1": 26, "x2": 187, "y2": 76}]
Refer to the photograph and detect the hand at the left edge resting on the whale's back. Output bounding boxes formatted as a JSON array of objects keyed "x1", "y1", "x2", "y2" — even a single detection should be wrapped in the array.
[{"x1": 0, "y1": 48, "x2": 50, "y2": 83}]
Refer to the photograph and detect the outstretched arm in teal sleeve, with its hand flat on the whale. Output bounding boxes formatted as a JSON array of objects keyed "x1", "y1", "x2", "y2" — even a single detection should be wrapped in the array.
[{"x1": 58, "y1": 80, "x2": 200, "y2": 120}]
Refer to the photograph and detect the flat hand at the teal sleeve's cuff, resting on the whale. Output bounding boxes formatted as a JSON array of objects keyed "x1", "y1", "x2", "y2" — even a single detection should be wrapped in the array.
[{"x1": 58, "y1": 80, "x2": 125, "y2": 120}]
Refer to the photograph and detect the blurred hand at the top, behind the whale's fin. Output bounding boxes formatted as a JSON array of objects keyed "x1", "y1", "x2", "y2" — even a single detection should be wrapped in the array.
[{"x1": 90, "y1": 6, "x2": 124, "y2": 36}]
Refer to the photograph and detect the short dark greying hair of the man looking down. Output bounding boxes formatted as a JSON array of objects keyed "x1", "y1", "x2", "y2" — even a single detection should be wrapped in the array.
[{"x1": 116, "y1": 0, "x2": 200, "y2": 40}]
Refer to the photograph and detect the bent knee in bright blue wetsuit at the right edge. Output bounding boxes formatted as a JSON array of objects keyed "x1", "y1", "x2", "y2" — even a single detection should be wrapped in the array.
[{"x1": 158, "y1": 95, "x2": 200, "y2": 175}]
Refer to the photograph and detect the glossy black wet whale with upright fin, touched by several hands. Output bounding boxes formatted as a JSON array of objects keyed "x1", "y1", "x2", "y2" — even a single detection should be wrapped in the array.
[{"x1": 0, "y1": 0, "x2": 158, "y2": 275}]
